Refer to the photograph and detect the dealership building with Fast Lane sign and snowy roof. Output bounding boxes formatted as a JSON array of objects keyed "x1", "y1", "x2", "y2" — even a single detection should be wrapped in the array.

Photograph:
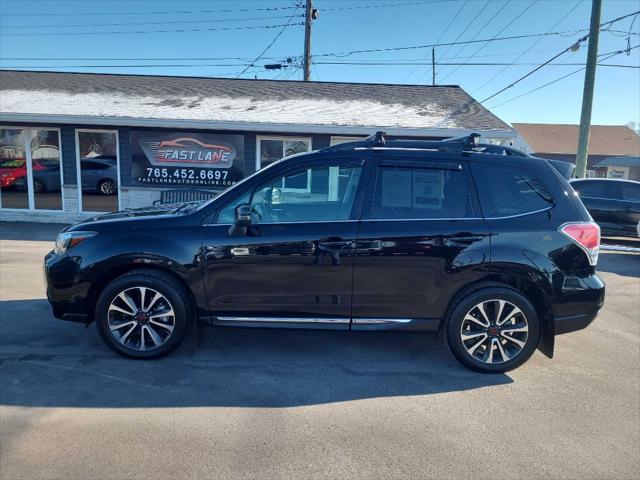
[{"x1": 0, "y1": 71, "x2": 517, "y2": 223}]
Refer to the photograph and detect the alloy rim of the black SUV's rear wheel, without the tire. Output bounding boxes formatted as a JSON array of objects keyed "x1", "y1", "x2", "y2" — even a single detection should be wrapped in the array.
[{"x1": 460, "y1": 299, "x2": 529, "y2": 364}]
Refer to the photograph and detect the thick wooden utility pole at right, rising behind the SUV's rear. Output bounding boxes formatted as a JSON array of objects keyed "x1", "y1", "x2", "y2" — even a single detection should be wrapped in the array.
[{"x1": 576, "y1": 0, "x2": 602, "y2": 178}]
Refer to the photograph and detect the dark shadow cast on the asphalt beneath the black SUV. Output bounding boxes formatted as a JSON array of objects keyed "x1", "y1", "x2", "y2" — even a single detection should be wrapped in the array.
[{"x1": 0, "y1": 300, "x2": 512, "y2": 408}]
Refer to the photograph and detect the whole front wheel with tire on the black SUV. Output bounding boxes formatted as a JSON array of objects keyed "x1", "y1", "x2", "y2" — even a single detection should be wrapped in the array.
[{"x1": 95, "y1": 270, "x2": 194, "y2": 359}]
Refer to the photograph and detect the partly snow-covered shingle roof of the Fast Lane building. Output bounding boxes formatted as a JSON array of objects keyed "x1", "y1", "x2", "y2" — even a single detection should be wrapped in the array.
[{"x1": 0, "y1": 71, "x2": 511, "y2": 131}]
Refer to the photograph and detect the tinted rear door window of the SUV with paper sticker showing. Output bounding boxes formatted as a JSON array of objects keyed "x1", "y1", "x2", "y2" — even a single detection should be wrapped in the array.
[{"x1": 366, "y1": 164, "x2": 474, "y2": 220}]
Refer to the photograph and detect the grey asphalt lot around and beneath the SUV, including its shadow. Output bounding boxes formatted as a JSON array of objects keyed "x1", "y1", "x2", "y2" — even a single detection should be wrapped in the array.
[{"x1": 0, "y1": 223, "x2": 640, "y2": 479}]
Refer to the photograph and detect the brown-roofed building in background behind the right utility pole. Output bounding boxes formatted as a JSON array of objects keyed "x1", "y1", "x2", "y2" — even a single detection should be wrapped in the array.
[{"x1": 513, "y1": 123, "x2": 640, "y2": 180}]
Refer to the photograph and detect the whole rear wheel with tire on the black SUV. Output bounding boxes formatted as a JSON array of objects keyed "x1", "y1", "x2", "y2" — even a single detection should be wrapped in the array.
[{"x1": 445, "y1": 284, "x2": 540, "y2": 373}]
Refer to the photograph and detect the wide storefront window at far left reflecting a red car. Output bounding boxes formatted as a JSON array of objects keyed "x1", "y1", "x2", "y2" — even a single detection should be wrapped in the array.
[{"x1": 0, "y1": 128, "x2": 62, "y2": 210}]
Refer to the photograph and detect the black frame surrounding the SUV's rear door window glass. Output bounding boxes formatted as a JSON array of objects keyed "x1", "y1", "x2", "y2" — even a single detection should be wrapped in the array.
[{"x1": 362, "y1": 156, "x2": 483, "y2": 222}]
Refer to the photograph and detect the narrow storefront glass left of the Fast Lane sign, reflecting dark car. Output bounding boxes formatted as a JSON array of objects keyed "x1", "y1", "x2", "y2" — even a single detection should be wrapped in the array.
[{"x1": 77, "y1": 130, "x2": 118, "y2": 212}]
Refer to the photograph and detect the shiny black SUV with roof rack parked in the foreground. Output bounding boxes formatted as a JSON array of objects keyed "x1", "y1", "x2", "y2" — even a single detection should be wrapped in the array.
[{"x1": 45, "y1": 133, "x2": 604, "y2": 372}]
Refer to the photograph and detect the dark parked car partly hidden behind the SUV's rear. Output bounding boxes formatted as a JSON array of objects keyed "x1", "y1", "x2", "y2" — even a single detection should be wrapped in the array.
[{"x1": 571, "y1": 178, "x2": 640, "y2": 238}]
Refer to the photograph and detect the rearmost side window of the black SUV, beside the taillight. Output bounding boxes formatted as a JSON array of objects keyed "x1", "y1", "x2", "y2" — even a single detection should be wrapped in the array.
[{"x1": 472, "y1": 163, "x2": 553, "y2": 217}]
